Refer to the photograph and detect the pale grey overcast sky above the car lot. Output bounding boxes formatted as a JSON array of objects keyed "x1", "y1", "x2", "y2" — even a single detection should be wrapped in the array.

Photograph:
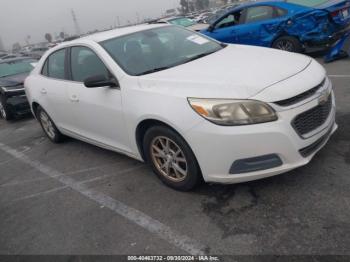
[{"x1": 0, "y1": 0, "x2": 180, "y2": 49}]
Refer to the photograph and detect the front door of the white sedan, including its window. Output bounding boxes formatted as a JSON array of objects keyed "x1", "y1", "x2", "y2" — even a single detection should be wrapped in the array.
[{"x1": 67, "y1": 46, "x2": 130, "y2": 154}]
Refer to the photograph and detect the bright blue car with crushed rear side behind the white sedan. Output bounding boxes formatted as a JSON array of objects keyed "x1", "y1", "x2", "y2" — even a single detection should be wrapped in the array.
[{"x1": 201, "y1": 0, "x2": 350, "y2": 52}]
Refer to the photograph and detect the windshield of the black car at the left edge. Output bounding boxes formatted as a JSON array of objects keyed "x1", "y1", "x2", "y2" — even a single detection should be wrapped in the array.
[{"x1": 0, "y1": 59, "x2": 36, "y2": 77}]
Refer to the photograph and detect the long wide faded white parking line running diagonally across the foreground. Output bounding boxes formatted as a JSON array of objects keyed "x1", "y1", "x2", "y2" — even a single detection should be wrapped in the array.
[{"x1": 0, "y1": 143, "x2": 205, "y2": 255}]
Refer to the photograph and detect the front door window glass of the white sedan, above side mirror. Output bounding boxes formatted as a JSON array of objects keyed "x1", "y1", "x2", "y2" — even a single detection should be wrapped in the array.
[{"x1": 71, "y1": 47, "x2": 109, "y2": 82}]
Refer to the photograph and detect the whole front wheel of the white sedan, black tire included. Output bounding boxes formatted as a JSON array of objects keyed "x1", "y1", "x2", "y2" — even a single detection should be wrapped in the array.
[{"x1": 143, "y1": 126, "x2": 202, "y2": 191}]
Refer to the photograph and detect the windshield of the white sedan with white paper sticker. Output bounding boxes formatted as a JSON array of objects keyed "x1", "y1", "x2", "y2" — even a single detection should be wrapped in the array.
[{"x1": 100, "y1": 26, "x2": 223, "y2": 76}]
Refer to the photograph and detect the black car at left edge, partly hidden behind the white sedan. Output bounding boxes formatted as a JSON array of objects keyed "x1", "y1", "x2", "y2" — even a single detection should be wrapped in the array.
[{"x1": 0, "y1": 57, "x2": 37, "y2": 120}]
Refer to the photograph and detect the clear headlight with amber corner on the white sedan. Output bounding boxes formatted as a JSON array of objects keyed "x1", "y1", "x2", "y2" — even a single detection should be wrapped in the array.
[{"x1": 188, "y1": 98, "x2": 278, "y2": 126}]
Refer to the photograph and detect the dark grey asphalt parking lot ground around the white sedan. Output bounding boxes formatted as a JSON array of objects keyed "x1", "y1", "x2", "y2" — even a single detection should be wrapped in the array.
[{"x1": 0, "y1": 56, "x2": 350, "y2": 255}]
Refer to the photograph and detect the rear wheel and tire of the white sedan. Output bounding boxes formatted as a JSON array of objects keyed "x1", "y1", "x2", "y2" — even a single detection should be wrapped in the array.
[{"x1": 36, "y1": 106, "x2": 64, "y2": 144}]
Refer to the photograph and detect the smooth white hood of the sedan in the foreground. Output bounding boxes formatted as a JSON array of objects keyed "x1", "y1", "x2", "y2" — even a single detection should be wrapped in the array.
[{"x1": 139, "y1": 45, "x2": 312, "y2": 99}]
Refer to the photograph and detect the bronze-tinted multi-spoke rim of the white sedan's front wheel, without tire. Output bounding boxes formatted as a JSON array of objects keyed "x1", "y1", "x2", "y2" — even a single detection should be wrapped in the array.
[{"x1": 151, "y1": 136, "x2": 188, "y2": 182}]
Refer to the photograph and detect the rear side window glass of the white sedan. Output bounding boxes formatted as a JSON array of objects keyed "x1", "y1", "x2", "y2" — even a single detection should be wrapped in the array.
[{"x1": 42, "y1": 49, "x2": 66, "y2": 79}]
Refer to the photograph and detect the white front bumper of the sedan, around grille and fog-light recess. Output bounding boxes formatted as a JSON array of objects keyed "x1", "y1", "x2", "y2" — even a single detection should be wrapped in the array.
[{"x1": 185, "y1": 89, "x2": 338, "y2": 184}]
